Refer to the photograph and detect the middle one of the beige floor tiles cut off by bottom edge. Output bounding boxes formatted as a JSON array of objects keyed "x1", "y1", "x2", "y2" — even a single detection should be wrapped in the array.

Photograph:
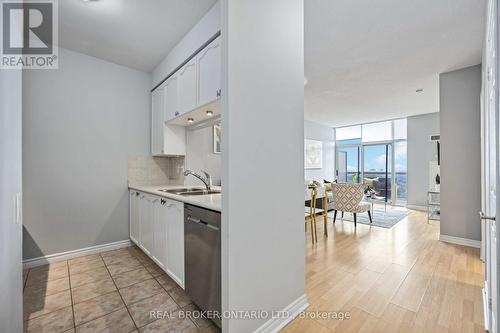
[{"x1": 76, "y1": 308, "x2": 136, "y2": 333}]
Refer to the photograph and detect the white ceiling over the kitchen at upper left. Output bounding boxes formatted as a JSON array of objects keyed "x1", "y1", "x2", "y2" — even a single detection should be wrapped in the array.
[{"x1": 59, "y1": 0, "x2": 216, "y2": 72}]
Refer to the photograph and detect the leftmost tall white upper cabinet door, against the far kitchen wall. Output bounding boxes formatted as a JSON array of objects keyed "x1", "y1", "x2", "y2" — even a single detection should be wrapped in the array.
[{"x1": 151, "y1": 87, "x2": 165, "y2": 156}]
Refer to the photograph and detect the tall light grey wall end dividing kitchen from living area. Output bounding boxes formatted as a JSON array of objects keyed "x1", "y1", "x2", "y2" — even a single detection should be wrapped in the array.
[{"x1": 222, "y1": 0, "x2": 305, "y2": 333}]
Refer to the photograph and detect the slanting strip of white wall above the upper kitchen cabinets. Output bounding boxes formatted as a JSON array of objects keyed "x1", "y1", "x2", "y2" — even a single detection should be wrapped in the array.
[{"x1": 151, "y1": 1, "x2": 221, "y2": 87}]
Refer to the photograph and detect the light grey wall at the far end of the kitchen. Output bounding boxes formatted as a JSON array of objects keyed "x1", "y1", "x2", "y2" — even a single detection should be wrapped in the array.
[{"x1": 23, "y1": 48, "x2": 151, "y2": 259}]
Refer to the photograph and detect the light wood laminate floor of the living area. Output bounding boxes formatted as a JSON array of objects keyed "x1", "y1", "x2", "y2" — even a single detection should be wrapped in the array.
[{"x1": 282, "y1": 211, "x2": 484, "y2": 333}]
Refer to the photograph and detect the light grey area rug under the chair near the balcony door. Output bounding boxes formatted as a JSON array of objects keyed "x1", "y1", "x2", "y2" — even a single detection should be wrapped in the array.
[{"x1": 328, "y1": 207, "x2": 408, "y2": 229}]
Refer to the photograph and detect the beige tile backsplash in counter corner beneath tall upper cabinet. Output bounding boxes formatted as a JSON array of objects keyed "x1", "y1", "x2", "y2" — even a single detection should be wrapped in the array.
[{"x1": 127, "y1": 156, "x2": 184, "y2": 185}]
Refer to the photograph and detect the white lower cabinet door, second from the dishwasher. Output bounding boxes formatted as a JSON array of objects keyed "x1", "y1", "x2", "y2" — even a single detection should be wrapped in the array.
[{"x1": 152, "y1": 199, "x2": 168, "y2": 270}]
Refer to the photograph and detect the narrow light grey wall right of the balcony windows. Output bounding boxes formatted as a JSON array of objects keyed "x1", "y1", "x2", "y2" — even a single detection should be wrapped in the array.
[{"x1": 407, "y1": 113, "x2": 439, "y2": 209}]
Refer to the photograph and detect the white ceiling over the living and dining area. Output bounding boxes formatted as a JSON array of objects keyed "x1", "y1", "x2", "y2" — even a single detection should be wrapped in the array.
[{"x1": 305, "y1": 0, "x2": 485, "y2": 126}]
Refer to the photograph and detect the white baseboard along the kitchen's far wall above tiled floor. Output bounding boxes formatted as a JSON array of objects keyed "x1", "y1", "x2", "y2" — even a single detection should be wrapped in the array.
[{"x1": 23, "y1": 239, "x2": 131, "y2": 268}]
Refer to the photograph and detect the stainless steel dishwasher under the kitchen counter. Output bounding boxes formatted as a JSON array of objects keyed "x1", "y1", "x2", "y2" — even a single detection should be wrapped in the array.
[{"x1": 184, "y1": 204, "x2": 221, "y2": 327}]
